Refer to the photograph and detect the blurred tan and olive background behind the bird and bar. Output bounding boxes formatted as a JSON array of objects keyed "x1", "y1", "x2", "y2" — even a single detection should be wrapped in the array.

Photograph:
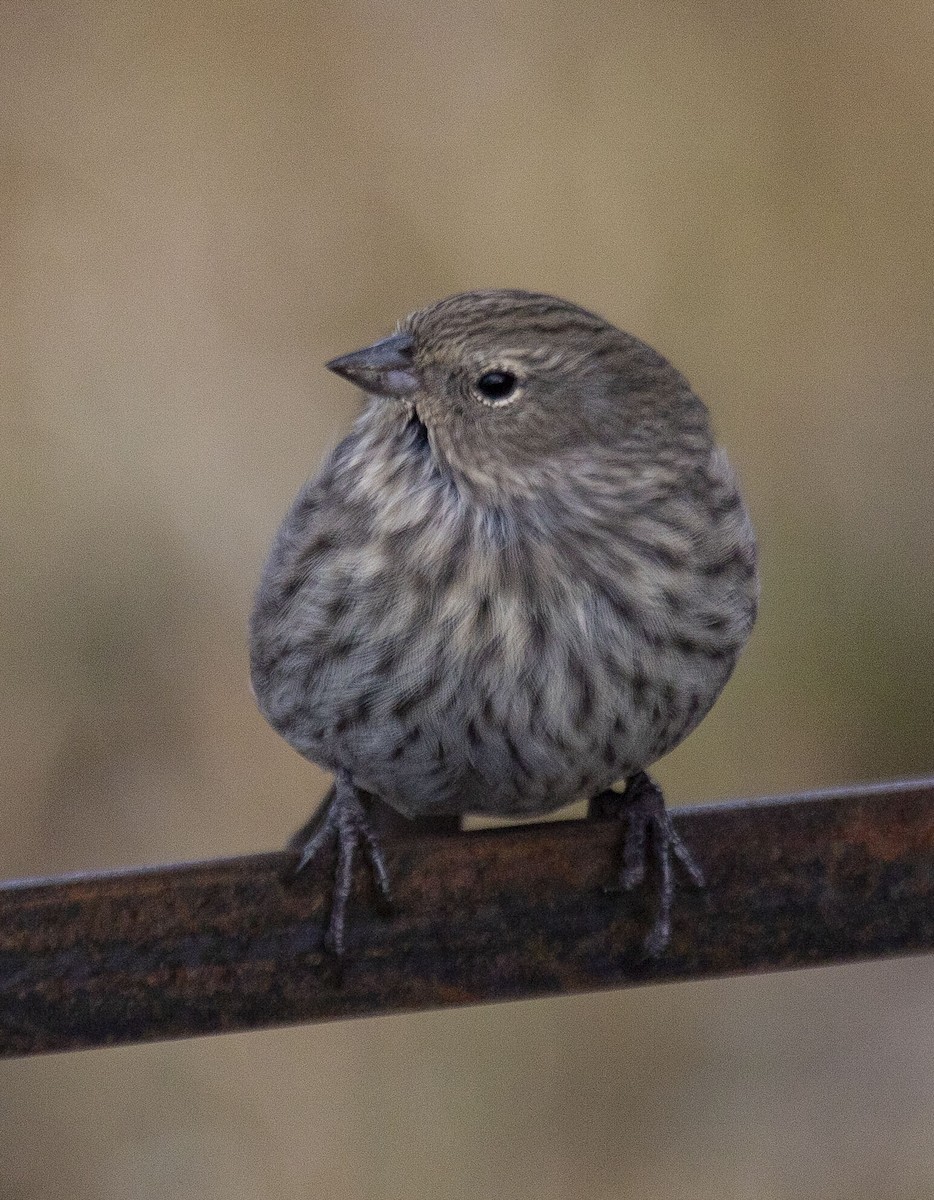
[{"x1": 0, "y1": 0, "x2": 934, "y2": 1200}]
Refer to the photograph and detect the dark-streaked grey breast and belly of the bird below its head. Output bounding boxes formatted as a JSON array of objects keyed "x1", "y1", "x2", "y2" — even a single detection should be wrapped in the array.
[{"x1": 255, "y1": 436, "x2": 752, "y2": 812}]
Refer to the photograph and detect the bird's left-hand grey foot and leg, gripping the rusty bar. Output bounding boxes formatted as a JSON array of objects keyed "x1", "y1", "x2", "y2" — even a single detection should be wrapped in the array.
[{"x1": 289, "y1": 772, "x2": 393, "y2": 959}]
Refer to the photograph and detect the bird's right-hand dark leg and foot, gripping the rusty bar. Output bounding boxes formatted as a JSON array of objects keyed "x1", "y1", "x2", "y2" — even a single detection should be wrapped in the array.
[{"x1": 588, "y1": 770, "x2": 704, "y2": 958}]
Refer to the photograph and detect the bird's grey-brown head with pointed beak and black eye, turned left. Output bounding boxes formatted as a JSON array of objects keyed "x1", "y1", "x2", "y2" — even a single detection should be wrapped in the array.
[{"x1": 328, "y1": 289, "x2": 711, "y2": 494}]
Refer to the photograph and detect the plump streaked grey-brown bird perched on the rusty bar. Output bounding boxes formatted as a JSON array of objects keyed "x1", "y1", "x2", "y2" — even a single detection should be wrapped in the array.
[{"x1": 250, "y1": 289, "x2": 759, "y2": 958}]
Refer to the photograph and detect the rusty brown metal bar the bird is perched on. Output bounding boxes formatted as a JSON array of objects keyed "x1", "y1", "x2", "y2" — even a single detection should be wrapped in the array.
[{"x1": 0, "y1": 780, "x2": 934, "y2": 1055}]
